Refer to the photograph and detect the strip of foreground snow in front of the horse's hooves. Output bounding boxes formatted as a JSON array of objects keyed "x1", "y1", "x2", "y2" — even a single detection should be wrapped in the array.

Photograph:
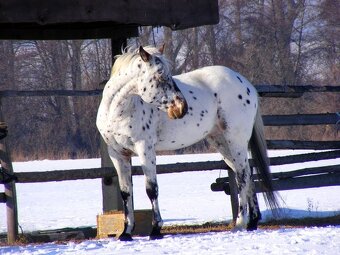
[{"x1": 0, "y1": 227, "x2": 340, "y2": 255}]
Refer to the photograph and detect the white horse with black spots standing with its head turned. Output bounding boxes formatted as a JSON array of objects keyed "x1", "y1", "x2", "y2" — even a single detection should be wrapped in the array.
[{"x1": 97, "y1": 44, "x2": 278, "y2": 240}]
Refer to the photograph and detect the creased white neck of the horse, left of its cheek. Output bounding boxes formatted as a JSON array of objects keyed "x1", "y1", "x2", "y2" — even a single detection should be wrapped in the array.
[{"x1": 101, "y1": 76, "x2": 137, "y2": 118}]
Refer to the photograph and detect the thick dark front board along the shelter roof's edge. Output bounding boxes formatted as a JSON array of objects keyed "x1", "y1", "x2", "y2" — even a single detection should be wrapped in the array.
[{"x1": 0, "y1": 0, "x2": 219, "y2": 28}]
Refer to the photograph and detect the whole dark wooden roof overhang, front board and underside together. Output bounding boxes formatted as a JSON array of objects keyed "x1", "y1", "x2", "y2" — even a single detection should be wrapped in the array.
[{"x1": 0, "y1": 0, "x2": 219, "y2": 40}]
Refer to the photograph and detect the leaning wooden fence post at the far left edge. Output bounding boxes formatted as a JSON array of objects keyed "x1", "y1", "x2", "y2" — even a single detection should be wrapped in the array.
[{"x1": 0, "y1": 98, "x2": 18, "y2": 244}]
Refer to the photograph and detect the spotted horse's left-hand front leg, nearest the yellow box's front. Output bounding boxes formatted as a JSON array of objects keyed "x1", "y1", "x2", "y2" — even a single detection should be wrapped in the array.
[{"x1": 108, "y1": 147, "x2": 135, "y2": 241}]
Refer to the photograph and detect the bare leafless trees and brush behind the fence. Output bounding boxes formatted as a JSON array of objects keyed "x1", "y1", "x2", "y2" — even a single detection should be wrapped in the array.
[{"x1": 0, "y1": 0, "x2": 340, "y2": 159}]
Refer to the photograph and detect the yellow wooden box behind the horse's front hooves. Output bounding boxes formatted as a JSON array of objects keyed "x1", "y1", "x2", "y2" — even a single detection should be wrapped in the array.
[{"x1": 97, "y1": 210, "x2": 152, "y2": 238}]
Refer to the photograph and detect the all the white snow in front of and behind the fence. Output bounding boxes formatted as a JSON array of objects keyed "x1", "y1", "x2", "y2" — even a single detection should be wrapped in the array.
[{"x1": 0, "y1": 151, "x2": 340, "y2": 255}]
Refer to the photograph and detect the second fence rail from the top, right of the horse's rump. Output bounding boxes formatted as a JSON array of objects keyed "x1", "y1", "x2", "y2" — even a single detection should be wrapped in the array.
[{"x1": 262, "y1": 113, "x2": 340, "y2": 126}]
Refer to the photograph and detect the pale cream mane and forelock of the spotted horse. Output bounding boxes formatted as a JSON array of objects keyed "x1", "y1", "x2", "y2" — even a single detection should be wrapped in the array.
[{"x1": 111, "y1": 45, "x2": 171, "y2": 76}]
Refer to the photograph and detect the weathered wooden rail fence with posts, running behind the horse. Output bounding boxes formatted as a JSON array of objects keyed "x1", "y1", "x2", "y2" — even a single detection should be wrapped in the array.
[{"x1": 0, "y1": 85, "x2": 340, "y2": 243}]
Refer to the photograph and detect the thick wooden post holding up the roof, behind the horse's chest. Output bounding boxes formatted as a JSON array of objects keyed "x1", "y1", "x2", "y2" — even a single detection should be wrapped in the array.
[{"x1": 100, "y1": 38, "x2": 126, "y2": 212}]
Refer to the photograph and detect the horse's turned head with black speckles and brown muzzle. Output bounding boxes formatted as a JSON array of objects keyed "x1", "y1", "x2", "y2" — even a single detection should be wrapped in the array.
[{"x1": 138, "y1": 46, "x2": 188, "y2": 119}]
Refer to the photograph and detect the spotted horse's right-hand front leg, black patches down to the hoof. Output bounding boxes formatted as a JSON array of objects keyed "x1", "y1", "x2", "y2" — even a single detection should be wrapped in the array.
[{"x1": 136, "y1": 141, "x2": 163, "y2": 240}]
